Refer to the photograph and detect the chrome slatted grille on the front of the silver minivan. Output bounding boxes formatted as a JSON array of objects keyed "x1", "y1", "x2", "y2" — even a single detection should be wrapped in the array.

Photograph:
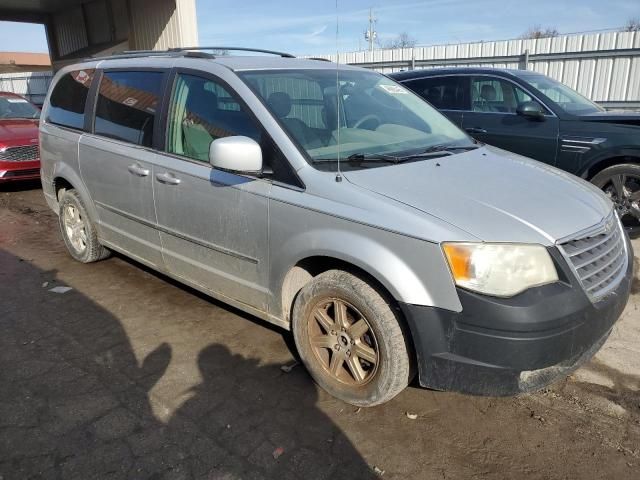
[{"x1": 560, "y1": 213, "x2": 627, "y2": 301}]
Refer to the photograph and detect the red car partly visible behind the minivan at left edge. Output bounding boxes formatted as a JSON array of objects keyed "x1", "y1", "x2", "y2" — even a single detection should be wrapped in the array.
[{"x1": 0, "y1": 92, "x2": 40, "y2": 183}]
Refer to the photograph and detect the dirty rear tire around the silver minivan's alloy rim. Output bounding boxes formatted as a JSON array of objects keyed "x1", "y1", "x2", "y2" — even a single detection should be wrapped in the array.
[{"x1": 58, "y1": 189, "x2": 111, "y2": 263}]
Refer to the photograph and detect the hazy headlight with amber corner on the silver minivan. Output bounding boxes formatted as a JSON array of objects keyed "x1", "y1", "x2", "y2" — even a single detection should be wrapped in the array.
[{"x1": 442, "y1": 243, "x2": 558, "y2": 297}]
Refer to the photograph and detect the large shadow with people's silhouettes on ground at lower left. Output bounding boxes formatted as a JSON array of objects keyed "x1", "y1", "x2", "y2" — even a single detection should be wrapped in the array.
[{"x1": 0, "y1": 250, "x2": 375, "y2": 480}]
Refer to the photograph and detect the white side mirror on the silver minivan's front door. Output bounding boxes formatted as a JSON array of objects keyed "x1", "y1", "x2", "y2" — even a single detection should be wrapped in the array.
[{"x1": 209, "y1": 136, "x2": 262, "y2": 173}]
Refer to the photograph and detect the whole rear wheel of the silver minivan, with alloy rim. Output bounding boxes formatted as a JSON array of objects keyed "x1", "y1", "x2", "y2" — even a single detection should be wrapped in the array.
[{"x1": 58, "y1": 190, "x2": 110, "y2": 263}]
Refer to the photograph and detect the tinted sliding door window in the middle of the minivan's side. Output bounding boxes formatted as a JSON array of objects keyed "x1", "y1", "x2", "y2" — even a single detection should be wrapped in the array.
[{"x1": 94, "y1": 71, "x2": 164, "y2": 147}]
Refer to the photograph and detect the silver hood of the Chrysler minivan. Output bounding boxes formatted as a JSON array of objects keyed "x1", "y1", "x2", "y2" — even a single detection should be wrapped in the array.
[{"x1": 343, "y1": 146, "x2": 613, "y2": 245}]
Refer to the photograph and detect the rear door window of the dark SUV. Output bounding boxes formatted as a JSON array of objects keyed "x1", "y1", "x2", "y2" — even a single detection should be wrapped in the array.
[{"x1": 406, "y1": 76, "x2": 469, "y2": 110}]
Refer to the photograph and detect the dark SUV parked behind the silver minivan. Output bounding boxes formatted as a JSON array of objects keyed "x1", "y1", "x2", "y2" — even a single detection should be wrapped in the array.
[{"x1": 390, "y1": 68, "x2": 640, "y2": 234}]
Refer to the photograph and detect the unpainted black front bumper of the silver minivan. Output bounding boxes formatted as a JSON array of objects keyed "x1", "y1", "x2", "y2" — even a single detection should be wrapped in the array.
[{"x1": 400, "y1": 239, "x2": 633, "y2": 395}]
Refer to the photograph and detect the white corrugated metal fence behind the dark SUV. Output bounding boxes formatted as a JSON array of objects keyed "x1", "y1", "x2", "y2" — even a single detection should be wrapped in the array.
[{"x1": 323, "y1": 32, "x2": 640, "y2": 107}]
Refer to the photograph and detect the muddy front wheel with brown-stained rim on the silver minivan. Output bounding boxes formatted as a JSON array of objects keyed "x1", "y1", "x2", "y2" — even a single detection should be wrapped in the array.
[{"x1": 292, "y1": 270, "x2": 412, "y2": 407}]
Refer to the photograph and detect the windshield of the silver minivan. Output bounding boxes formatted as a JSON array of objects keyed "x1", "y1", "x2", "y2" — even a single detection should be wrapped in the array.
[{"x1": 240, "y1": 69, "x2": 474, "y2": 168}]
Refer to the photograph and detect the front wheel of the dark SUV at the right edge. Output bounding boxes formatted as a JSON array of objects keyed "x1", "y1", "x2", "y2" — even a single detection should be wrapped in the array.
[{"x1": 591, "y1": 163, "x2": 640, "y2": 236}]
